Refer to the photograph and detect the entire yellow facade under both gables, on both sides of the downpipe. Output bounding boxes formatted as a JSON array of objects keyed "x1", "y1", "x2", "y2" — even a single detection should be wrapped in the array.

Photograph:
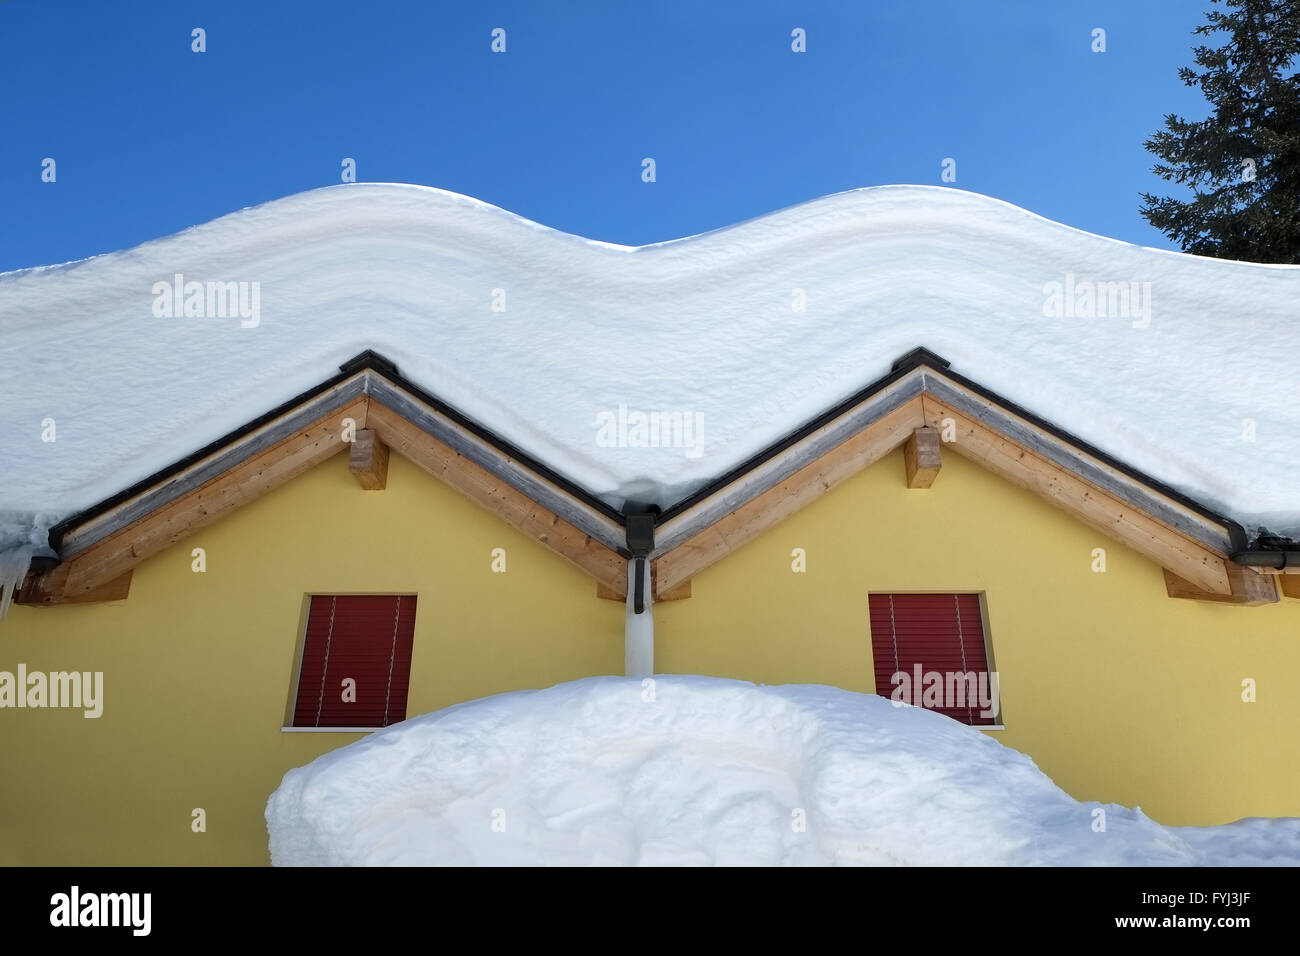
[{"x1": 0, "y1": 444, "x2": 1300, "y2": 864}]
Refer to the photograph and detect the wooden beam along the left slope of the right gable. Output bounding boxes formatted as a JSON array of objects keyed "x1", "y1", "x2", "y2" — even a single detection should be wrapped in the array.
[{"x1": 660, "y1": 397, "x2": 926, "y2": 591}]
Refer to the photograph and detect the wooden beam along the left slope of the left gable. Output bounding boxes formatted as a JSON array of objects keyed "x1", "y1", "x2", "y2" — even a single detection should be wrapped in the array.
[{"x1": 27, "y1": 395, "x2": 369, "y2": 604}]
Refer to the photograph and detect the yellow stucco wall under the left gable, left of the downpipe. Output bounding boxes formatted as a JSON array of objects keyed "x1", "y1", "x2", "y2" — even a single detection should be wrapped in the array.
[{"x1": 0, "y1": 455, "x2": 623, "y2": 865}]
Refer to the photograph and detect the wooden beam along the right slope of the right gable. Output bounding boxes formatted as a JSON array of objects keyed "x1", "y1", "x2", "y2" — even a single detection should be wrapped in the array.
[{"x1": 922, "y1": 393, "x2": 1232, "y2": 596}]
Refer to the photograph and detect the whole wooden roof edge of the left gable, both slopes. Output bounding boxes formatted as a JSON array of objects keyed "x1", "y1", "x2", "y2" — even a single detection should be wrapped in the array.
[{"x1": 14, "y1": 367, "x2": 627, "y2": 605}]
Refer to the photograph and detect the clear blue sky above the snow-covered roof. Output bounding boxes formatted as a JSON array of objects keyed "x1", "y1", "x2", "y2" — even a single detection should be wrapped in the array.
[{"x1": 0, "y1": 0, "x2": 1210, "y2": 271}]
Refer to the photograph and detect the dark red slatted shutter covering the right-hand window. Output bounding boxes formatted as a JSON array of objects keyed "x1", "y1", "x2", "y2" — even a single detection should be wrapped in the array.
[{"x1": 868, "y1": 594, "x2": 997, "y2": 726}]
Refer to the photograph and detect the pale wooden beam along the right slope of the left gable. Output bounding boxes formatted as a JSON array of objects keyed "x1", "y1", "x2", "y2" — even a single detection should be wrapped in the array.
[{"x1": 367, "y1": 398, "x2": 628, "y2": 591}]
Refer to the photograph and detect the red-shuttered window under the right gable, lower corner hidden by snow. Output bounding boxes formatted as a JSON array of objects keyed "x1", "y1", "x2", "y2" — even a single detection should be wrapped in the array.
[{"x1": 868, "y1": 594, "x2": 998, "y2": 726}]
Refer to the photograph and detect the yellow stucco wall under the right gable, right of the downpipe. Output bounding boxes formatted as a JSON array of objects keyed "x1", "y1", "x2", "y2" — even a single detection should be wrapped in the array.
[{"x1": 655, "y1": 451, "x2": 1300, "y2": 826}]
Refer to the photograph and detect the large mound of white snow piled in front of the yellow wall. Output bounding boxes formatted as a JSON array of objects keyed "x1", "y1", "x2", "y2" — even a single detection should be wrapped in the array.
[{"x1": 267, "y1": 676, "x2": 1300, "y2": 866}]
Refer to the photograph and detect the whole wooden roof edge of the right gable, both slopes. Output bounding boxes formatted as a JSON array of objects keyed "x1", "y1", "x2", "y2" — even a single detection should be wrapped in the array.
[{"x1": 651, "y1": 367, "x2": 1258, "y2": 604}]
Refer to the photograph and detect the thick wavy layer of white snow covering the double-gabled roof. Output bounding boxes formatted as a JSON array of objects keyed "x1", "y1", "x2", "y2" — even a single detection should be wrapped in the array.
[{"x1": 0, "y1": 183, "x2": 1300, "y2": 548}]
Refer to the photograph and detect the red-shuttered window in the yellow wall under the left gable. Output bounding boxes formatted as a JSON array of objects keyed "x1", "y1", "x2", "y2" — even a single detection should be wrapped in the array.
[{"x1": 293, "y1": 594, "x2": 416, "y2": 727}]
